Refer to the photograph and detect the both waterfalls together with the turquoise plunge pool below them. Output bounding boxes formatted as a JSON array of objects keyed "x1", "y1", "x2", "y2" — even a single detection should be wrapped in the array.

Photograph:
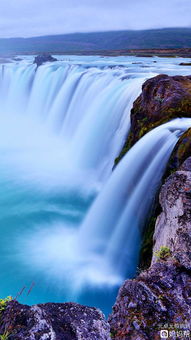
[{"x1": 0, "y1": 56, "x2": 191, "y2": 311}]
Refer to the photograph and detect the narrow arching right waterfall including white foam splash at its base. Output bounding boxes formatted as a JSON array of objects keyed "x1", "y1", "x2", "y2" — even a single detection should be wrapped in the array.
[{"x1": 19, "y1": 118, "x2": 191, "y2": 293}]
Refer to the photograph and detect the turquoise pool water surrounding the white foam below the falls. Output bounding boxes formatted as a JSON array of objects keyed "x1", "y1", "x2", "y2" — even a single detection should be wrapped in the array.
[{"x1": 0, "y1": 169, "x2": 117, "y2": 313}]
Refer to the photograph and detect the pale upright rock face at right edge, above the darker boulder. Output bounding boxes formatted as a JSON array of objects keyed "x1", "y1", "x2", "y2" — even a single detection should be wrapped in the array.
[{"x1": 152, "y1": 158, "x2": 191, "y2": 270}]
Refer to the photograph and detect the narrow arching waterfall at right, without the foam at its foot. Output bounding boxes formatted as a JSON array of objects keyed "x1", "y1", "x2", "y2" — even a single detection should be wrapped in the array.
[{"x1": 79, "y1": 119, "x2": 191, "y2": 278}]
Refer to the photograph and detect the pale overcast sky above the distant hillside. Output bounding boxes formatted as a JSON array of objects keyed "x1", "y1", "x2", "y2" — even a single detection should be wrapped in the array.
[{"x1": 0, "y1": 0, "x2": 191, "y2": 37}]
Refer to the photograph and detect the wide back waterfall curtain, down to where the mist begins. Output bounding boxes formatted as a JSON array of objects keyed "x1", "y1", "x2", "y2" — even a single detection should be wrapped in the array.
[{"x1": 0, "y1": 62, "x2": 144, "y2": 181}]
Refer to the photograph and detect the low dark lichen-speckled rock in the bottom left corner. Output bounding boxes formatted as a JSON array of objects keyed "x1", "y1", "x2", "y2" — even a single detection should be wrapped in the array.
[{"x1": 0, "y1": 301, "x2": 110, "y2": 340}]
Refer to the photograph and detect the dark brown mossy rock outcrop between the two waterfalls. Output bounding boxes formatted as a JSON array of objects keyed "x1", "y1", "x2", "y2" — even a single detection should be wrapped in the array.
[{"x1": 116, "y1": 74, "x2": 191, "y2": 163}]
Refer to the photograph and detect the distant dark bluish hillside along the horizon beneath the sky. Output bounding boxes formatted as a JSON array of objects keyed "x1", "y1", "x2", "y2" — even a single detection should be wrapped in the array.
[{"x1": 0, "y1": 28, "x2": 191, "y2": 54}]
